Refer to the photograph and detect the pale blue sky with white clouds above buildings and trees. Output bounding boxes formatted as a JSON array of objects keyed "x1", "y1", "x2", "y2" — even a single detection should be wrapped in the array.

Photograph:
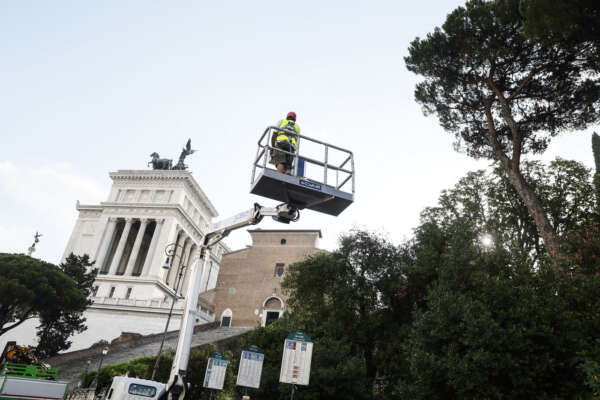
[{"x1": 0, "y1": 0, "x2": 598, "y2": 262}]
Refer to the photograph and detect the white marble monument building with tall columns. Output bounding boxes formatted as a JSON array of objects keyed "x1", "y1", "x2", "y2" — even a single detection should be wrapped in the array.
[{"x1": 0, "y1": 170, "x2": 228, "y2": 350}]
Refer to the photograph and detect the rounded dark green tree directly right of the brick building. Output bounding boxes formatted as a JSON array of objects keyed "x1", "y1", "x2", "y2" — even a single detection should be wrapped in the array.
[{"x1": 282, "y1": 230, "x2": 403, "y2": 387}]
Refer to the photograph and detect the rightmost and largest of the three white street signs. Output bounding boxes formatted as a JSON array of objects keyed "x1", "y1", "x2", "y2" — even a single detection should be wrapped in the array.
[{"x1": 279, "y1": 332, "x2": 313, "y2": 385}]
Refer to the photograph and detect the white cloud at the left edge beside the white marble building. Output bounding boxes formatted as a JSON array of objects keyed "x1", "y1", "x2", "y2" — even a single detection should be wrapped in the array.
[{"x1": 0, "y1": 161, "x2": 108, "y2": 262}]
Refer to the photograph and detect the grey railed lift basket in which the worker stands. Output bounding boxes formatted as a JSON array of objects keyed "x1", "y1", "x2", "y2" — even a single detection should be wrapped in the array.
[{"x1": 250, "y1": 126, "x2": 354, "y2": 216}]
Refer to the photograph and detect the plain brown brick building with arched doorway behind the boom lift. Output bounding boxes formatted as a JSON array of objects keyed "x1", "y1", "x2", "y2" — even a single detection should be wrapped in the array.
[{"x1": 214, "y1": 229, "x2": 322, "y2": 326}]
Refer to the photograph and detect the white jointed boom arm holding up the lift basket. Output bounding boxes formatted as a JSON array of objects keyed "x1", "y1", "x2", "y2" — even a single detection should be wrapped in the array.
[{"x1": 162, "y1": 204, "x2": 299, "y2": 400}]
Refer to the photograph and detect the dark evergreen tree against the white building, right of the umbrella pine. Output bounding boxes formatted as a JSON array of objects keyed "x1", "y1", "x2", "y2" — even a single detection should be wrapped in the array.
[{"x1": 36, "y1": 253, "x2": 98, "y2": 359}]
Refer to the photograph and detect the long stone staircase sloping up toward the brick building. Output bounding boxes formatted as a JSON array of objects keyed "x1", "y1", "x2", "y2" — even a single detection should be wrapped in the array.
[{"x1": 47, "y1": 323, "x2": 254, "y2": 383}]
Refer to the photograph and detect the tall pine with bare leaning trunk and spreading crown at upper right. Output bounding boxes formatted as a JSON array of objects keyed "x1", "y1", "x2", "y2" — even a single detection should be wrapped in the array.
[{"x1": 405, "y1": 0, "x2": 600, "y2": 255}]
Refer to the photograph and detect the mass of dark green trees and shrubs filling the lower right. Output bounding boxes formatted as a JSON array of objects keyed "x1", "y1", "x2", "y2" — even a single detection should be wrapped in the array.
[{"x1": 76, "y1": 155, "x2": 600, "y2": 400}]
